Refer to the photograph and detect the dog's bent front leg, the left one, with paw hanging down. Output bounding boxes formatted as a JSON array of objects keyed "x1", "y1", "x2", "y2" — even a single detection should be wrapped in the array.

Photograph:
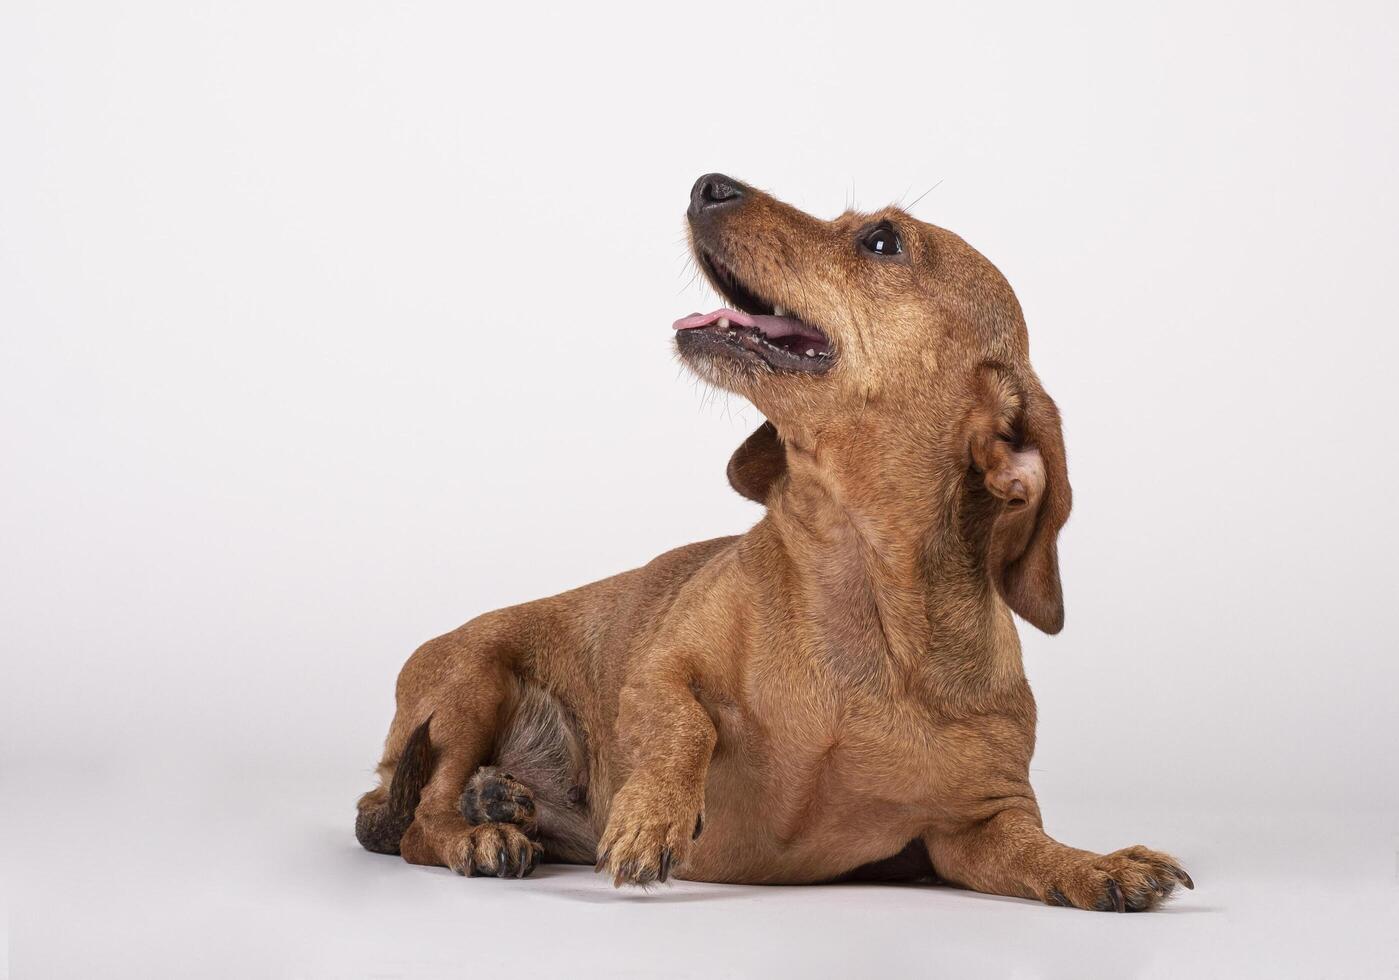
[{"x1": 597, "y1": 657, "x2": 716, "y2": 886}]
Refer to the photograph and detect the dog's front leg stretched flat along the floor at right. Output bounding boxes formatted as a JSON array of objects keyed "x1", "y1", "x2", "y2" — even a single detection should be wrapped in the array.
[{"x1": 923, "y1": 798, "x2": 1195, "y2": 911}]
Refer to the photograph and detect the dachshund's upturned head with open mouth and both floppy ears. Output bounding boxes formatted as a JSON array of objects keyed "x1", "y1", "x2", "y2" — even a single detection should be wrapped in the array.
[{"x1": 676, "y1": 173, "x2": 1070, "y2": 633}]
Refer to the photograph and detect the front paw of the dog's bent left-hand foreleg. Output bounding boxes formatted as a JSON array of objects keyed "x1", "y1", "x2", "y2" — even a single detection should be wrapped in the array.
[{"x1": 596, "y1": 780, "x2": 704, "y2": 888}]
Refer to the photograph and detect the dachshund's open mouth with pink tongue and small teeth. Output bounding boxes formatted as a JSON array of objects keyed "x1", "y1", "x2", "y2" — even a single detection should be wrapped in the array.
[{"x1": 674, "y1": 250, "x2": 835, "y2": 373}]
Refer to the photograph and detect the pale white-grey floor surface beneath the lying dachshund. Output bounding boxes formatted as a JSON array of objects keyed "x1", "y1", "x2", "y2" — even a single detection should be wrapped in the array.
[{"x1": 0, "y1": 772, "x2": 1399, "y2": 980}]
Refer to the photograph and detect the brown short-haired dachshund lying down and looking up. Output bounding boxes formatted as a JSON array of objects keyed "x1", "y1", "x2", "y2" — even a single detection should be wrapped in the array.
[{"x1": 355, "y1": 173, "x2": 1193, "y2": 911}]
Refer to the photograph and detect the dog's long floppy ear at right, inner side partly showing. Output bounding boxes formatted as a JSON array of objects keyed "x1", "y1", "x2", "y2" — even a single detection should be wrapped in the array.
[{"x1": 971, "y1": 373, "x2": 1073, "y2": 633}]
